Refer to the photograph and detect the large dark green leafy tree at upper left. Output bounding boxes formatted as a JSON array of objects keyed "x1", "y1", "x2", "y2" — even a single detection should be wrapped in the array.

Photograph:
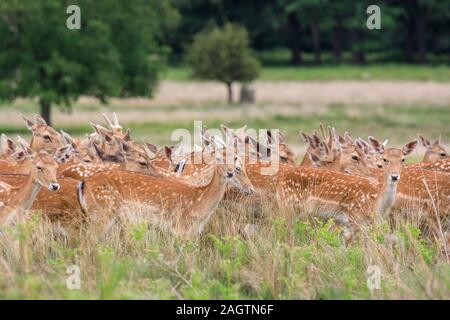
[{"x1": 0, "y1": 0, "x2": 178, "y2": 123}]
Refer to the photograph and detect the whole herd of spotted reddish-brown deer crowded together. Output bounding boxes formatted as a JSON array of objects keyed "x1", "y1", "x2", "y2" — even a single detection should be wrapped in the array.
[{"x1": 0, "y1": 114, "x2": 450, "y2": 244}]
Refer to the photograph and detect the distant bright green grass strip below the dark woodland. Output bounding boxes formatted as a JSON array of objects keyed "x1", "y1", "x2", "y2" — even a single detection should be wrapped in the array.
[{"x1": 162, "y1": 63, "x2": 450, "y2": 82}]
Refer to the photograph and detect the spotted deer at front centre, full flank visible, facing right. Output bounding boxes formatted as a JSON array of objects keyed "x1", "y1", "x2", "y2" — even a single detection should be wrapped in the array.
[{"x1": 78, "y1": 138, "x2": 253, "y2": 237}]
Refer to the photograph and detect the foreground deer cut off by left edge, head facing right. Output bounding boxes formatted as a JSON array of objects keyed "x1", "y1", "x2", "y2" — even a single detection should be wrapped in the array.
[{"x1": 0, "y1": 141, "x2": 60, "y2": 225}]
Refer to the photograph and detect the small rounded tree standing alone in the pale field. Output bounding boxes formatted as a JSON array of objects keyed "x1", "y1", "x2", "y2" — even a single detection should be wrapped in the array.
[{"x1": 186, "y1": 24, "x2": 259, "y2": 103}]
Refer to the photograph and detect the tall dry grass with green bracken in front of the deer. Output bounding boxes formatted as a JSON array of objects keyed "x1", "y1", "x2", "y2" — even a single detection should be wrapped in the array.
[{"x1": 0, "y1": 198, "x2": 450, "y2": 299}]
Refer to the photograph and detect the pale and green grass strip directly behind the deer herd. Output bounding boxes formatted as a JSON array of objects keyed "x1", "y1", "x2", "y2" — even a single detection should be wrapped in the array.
[{"x1": 0, "y1": 102, "x2": 450, "y2": 156}]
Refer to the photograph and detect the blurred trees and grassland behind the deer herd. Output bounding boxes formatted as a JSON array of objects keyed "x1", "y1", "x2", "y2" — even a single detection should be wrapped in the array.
[{"x1": 0, "y1": 0, "x2": 450, "y2": 158}]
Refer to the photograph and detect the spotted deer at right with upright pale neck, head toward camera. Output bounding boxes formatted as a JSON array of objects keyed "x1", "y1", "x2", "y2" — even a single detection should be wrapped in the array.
[{"x1": 277, "y1": 140, "x2": 417, "y2": 232}]
